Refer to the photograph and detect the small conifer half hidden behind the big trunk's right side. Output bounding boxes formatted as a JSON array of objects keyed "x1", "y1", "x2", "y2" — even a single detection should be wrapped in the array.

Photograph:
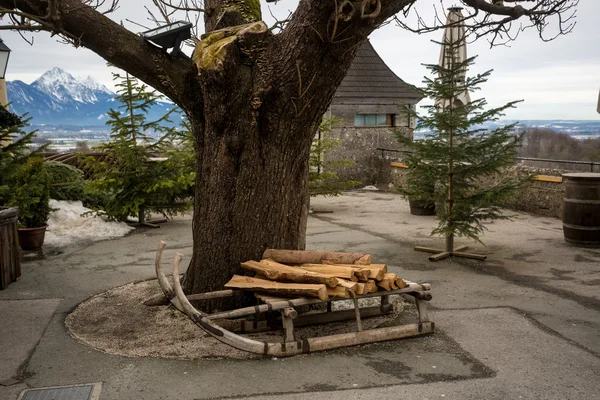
[{"x1": 308, "y1": 117, "x2": 361, "y2": 196}]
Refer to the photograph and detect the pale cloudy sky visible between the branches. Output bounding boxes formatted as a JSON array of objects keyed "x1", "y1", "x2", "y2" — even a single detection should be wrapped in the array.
[{"x1": 2, "y1": 0, "x2": 600, "y2": 120}]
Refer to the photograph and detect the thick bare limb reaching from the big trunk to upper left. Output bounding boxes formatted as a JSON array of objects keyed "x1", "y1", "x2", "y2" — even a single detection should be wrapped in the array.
[{"x1": 0, "y1": 0, "x2": 198, "y2": 105}]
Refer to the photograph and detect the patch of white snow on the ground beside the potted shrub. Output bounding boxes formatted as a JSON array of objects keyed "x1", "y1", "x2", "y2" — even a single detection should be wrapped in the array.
[{"x1": 44, "y1": 200, "x2": 134, "y2": 247}]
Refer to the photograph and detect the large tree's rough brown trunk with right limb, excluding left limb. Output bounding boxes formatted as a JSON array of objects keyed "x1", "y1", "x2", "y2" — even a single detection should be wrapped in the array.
[{"x1": 184, "y1": 2, "x2": 392, "y2": 302}]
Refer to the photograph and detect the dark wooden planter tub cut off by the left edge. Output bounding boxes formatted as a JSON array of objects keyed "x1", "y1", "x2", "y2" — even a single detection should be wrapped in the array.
[{"x1": 0, "y1": 208, "x2": 21, "y2": 289}]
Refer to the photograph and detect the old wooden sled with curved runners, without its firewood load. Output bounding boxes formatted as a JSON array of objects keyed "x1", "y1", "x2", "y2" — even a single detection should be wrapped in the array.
[{"x1": 155, "y1": 242, "x2": 435, "y2": 357}]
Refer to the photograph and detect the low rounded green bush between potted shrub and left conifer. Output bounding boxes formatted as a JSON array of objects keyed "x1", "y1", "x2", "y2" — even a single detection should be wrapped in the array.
[{"x1": 46, "y1": 161, "x2": 85, "y2": 200}]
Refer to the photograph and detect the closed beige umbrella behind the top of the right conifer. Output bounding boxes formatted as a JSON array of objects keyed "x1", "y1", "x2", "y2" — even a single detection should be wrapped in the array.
[{"x1": 436, "y1": 7, "x2": 471, "y2": 108}]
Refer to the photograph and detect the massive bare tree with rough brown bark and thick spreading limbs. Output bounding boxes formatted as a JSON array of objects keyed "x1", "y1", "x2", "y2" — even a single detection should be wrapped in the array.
[{"x1": 0, "y1": 0, "x2": 412, "y2": 306}]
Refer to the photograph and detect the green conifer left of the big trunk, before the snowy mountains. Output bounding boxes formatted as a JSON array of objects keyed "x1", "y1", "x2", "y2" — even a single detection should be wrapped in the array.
[{"x1": 87, "y1": 74, "x2": 193, "y2": 222}]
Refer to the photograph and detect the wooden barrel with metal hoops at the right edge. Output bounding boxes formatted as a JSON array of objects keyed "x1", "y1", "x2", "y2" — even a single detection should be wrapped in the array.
[{"x1": 562, "y1": 172, "x2": 600, "y2": 247}]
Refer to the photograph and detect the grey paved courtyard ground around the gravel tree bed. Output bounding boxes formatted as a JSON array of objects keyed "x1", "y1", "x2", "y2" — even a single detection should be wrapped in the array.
[{"x1": 0, "y1": 191, "x2": 600, "y2": 400}]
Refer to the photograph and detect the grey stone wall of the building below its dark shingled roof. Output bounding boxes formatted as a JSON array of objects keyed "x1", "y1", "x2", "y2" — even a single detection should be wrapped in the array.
[{"x1": 326, "y1": 104, "x2": 414, "y2": 186}]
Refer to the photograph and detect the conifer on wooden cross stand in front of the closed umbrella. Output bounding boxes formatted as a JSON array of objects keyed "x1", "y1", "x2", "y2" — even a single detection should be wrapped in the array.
[{"x1": 396, "y1": 41, "x2": 522, "y2": 260}]
